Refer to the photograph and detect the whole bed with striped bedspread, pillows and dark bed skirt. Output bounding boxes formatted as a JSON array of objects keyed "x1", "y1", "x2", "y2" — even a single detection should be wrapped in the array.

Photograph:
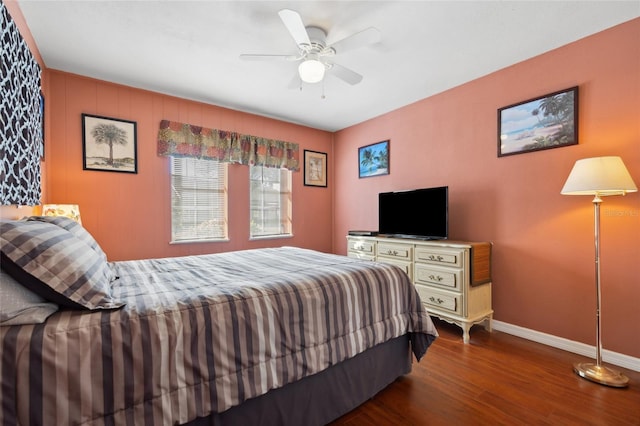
[{"x1": 0, "y1": 217, "x2": 437, "y2": 425}]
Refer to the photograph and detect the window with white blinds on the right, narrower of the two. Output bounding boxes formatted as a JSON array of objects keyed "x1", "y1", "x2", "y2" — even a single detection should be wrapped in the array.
[{"x1": 249, "y1": 166, "x2": 291, "y2": 238}]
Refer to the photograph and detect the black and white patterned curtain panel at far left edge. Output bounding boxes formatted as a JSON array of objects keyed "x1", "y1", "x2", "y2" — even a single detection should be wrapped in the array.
[{"x1": 0, "y1": 2, "x2": 44, "y2": 206}]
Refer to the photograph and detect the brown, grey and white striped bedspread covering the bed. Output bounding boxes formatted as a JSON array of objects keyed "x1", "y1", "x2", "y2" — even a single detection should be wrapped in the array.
[{"x1": 0, "y1": 247, "x2": 437, "y2": 425}]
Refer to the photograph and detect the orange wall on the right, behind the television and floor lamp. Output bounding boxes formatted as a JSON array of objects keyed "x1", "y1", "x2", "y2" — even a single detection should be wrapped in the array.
[{"x1": 334, "y1": 19, "x2": 640, "y2": 357}]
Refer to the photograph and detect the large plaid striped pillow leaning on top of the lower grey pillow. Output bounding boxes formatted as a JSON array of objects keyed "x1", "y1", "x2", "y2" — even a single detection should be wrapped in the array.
[{"x1": 0, "y1": 221, "x2": 124, "y2": 309}]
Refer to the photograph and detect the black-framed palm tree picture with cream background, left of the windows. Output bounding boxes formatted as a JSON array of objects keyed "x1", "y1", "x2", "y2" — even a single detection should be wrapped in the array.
[{"x1": 82, "y1": 114, "x2": 138, "y2": 173}]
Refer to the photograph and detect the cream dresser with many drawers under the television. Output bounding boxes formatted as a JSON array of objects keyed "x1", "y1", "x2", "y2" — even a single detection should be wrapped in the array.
[{"x1": 347, "y1": 235, "x2": 493, "y2": 343}]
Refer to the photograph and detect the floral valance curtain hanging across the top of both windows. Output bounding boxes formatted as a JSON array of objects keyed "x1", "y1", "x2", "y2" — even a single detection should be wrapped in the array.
[{"x1": 158, "y1": 120, "x2": 300, "y2": 171}]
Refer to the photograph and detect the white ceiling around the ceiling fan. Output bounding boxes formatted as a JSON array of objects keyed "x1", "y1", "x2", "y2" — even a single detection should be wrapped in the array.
[{"x1": 18, "y1": 0, "x2": 640, "y2": 131}]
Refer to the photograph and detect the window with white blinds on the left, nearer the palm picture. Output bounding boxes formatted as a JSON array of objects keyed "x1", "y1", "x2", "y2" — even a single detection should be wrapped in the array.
[{"x1": 171, "y1": 157, "x2": 227, "y2": 242}]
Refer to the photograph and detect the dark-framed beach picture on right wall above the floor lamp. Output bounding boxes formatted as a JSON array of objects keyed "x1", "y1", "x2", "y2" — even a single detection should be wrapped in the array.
[{"x1": 498, "y1": 86, "x2": 578, "y2": 157}]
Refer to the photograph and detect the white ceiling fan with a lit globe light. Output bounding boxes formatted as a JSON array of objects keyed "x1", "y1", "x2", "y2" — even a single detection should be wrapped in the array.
[{"x1": 240, "y1": 9, "x2": 380, "y2": 85}]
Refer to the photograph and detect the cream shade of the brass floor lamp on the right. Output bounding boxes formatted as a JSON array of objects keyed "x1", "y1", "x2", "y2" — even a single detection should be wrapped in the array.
[{"x1": 560, "y1": 157, "x2": 638, "y2": 196}]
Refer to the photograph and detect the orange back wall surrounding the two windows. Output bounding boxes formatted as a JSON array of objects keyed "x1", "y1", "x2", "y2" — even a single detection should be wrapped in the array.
[{"x1": 44, "y1": 70, "x2": 333, "y2": 261}]
